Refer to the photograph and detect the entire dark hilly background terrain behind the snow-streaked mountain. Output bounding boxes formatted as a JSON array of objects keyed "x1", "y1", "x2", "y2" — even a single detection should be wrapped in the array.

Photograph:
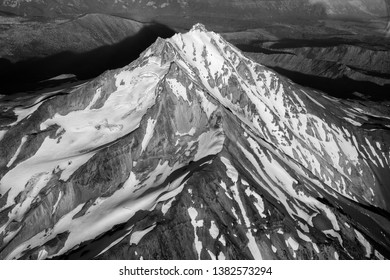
[{"x1": 0, "y1": 0, "x2": 390, "y2": 99}]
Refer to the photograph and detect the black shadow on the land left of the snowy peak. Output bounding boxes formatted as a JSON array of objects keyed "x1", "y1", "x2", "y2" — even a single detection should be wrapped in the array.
[{"x1": 0, "y1": 23, "x2": 175, "y2": 95}]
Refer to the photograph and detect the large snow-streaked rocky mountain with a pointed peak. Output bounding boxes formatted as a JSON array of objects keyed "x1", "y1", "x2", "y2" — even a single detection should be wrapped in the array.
[{"x1": 0, "y1": 25, "x2": 390, "y2": 259}]
